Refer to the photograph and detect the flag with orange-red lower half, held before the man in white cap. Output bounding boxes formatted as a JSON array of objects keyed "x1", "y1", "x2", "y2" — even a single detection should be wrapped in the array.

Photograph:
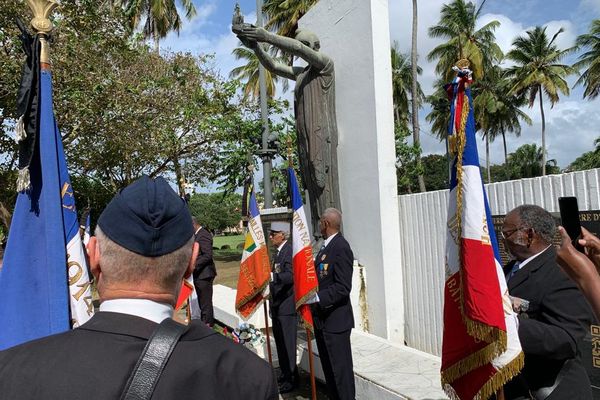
[{"x1": 235, "y1": 190, "x2": 271, "y2": 320}]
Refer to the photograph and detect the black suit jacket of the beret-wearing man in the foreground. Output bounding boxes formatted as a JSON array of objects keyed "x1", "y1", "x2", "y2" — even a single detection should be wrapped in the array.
[{"x1": 0, "y1": 312, "x2": 278, "y2": 400}]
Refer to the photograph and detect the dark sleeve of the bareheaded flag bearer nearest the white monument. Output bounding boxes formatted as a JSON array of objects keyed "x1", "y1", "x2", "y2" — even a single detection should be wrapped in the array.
[{"x1": 317, "y1": 241, "x2": 354, "y2": 308}]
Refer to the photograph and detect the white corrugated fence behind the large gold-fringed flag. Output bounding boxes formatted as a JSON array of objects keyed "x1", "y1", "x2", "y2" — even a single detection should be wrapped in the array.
[{"x1": 398, "y1": 169, "x2": 600, "y2": 355}]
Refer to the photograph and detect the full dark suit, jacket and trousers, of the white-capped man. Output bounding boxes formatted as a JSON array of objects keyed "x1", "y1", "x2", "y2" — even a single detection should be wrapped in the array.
[{"x1": 269, "y1": 240, "x2": 298, "y2": 383}]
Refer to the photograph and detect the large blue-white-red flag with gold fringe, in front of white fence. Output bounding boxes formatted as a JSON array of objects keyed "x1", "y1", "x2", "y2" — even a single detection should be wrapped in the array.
[{"x1": 441, "y1": 60, "x2": 524, "y2": 400}]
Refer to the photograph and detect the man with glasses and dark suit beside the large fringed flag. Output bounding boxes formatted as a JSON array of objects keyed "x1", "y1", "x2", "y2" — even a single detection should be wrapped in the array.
[{"x1": 501, "y1": 205, "x2": 592, "y2": 400}]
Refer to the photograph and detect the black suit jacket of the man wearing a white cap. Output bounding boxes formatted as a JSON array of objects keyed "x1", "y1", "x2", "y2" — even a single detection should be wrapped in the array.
[{"x1": 269, "y1": 240, "x2": 296, "y2": 315}]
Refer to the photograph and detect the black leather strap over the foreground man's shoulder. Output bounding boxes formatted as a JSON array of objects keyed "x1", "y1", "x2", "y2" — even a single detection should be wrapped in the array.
[{"x1": 121, "y1": 318, "x2": 188, "y2": 400}]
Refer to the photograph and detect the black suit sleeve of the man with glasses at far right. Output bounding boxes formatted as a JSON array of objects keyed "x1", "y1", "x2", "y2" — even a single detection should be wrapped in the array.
[{"x1": 519, "y1": 267, "x2": 591, "y2": 360}]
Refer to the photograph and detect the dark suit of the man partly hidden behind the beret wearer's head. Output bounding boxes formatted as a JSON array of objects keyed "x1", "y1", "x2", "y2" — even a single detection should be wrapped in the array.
[{"x1": 194, "y1": 228, "x2": 217, "y2": 325}]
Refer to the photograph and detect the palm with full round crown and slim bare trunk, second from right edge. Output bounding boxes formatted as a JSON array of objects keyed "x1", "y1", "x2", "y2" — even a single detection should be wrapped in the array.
[{"x1": 506, "y1": 26, "x2": 576, "y2": 175}]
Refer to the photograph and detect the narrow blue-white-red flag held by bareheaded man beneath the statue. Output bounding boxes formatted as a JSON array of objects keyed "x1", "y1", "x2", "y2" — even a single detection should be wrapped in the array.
[{"x1": 288, "y1": 167, "x2": 319, "y2": 331}]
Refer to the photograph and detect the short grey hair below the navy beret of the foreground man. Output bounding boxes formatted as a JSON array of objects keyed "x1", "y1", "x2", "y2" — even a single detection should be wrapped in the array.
[{"x1": 95, "y1": 226, "x2": 194, "y2": 291}]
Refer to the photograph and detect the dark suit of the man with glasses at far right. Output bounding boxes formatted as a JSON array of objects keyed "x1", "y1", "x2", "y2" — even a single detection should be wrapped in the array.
[{"x1": 504, "y1": 246, "x2": 592, "y2": 400}]
